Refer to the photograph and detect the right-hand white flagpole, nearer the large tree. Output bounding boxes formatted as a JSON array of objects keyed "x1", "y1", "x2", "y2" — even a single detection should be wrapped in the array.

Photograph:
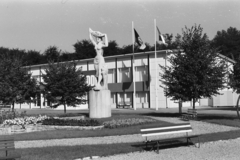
[{"x1": 154, "y1": 19, "x2": 158, "y2": 110}]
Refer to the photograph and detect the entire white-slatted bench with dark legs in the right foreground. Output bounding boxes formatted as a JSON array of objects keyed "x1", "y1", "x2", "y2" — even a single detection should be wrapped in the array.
[{"x1": 140, "y1": 123, "x2": 200, "y2": 153}]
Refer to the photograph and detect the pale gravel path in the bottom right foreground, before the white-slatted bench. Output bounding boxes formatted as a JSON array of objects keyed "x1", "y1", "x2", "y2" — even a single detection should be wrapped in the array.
[{"x1": 99, "y1": 138, "x2": 240, "y2": 160}]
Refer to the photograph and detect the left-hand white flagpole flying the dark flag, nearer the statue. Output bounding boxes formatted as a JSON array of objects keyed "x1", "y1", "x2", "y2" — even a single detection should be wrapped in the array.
[{"x1": 132, "y1": 21, "x2": 137, "y2": 110}]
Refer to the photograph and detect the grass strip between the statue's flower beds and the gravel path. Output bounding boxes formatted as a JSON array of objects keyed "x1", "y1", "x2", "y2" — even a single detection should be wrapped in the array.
[{"x1": 4, "y1": 115, "x2": 172, "y2": 141}]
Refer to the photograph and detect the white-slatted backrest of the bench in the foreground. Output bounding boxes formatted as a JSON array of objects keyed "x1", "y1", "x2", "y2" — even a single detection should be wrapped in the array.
[{"x1": 141, "y1": 123, "x2": 192, "y2": 137}]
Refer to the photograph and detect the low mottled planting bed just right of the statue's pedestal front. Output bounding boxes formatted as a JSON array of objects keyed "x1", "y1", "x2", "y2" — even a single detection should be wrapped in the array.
[{"x1": 103, "y1": 118, "x2": 156, "y2": 128}]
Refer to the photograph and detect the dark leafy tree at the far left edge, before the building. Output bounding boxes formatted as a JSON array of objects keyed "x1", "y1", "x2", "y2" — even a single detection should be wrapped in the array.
[{"x1": 0, "y1": 54, "x2": 37, "y2": 110}]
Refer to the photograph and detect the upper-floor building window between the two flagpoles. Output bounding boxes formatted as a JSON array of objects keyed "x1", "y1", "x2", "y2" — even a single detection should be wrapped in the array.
[{"x1": 135, "y1": 66, "x2": 148, "y2": 82}]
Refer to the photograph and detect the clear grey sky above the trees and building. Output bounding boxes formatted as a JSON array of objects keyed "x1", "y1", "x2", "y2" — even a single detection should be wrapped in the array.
[{"x1": 0, "y1": 0, "x2": 240, "y2": 53}]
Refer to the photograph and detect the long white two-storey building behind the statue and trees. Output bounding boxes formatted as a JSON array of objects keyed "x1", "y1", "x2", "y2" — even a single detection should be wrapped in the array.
[{"x1": 15, "y1": 50, "x2": 236, "y2": 109}]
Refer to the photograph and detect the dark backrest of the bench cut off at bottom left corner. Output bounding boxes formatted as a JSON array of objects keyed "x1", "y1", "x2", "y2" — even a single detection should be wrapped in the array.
[{"x1": 0, "y1": 136, "x2": 15, "y2": 151}]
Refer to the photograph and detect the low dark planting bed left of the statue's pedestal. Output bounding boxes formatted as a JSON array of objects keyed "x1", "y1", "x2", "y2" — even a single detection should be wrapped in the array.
[{"x1": 42, "y1": 118, "x2": 101, "y2": 126}]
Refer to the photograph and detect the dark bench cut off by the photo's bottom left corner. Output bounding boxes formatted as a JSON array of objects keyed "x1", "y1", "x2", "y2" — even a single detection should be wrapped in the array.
[{"x1": 0, "y1": 136, "x2": 21, "y2": 159}]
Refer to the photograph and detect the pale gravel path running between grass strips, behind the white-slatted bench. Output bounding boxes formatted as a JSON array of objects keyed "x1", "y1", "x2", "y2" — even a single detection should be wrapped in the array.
[{"x1": 15, "y1": 117, "x2": 239, "y2": 148}]
